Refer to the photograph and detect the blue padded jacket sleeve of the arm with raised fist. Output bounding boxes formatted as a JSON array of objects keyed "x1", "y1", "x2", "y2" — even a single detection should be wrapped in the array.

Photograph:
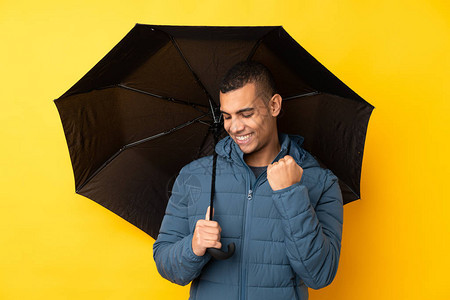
[{"x1": 268, "y1": 155, "x2": 343, "y2": 289}]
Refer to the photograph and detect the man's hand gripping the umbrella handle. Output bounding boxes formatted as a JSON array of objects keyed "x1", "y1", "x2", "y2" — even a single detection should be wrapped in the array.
[{"x1": 192, "y1": 206, "x2": 222, "y2": 256}]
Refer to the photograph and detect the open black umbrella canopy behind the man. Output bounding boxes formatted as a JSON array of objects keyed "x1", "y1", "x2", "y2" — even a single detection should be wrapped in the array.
[{"x1": 55, "y1": 24, "x2": 373, "y2": 238}]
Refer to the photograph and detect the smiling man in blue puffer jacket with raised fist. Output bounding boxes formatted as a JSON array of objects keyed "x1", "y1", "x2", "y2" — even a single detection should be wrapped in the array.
[{"x1": 154, "y1": 61, "x2": 343, "y2": 300}]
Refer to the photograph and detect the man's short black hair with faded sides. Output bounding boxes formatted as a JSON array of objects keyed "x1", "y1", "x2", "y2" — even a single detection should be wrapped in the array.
[{"x1": 219, "y1": 60, "x2": 276, "y2": 101}]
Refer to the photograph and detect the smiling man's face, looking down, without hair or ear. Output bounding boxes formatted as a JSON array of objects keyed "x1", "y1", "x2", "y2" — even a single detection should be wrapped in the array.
[{"x1": 220, "y1": 83, "x2": 277, "y2": 154}]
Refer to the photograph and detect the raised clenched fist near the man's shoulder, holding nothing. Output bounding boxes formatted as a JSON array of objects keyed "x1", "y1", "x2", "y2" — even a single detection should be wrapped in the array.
[{"x1": 267, "y1": 155, "x2": 303, "y2": 191}]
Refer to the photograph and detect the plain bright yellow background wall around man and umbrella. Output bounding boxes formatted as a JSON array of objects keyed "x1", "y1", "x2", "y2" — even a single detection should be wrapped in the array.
[{"x1": 0, "y1": 0, "x2": 450, "y2": 300}]
